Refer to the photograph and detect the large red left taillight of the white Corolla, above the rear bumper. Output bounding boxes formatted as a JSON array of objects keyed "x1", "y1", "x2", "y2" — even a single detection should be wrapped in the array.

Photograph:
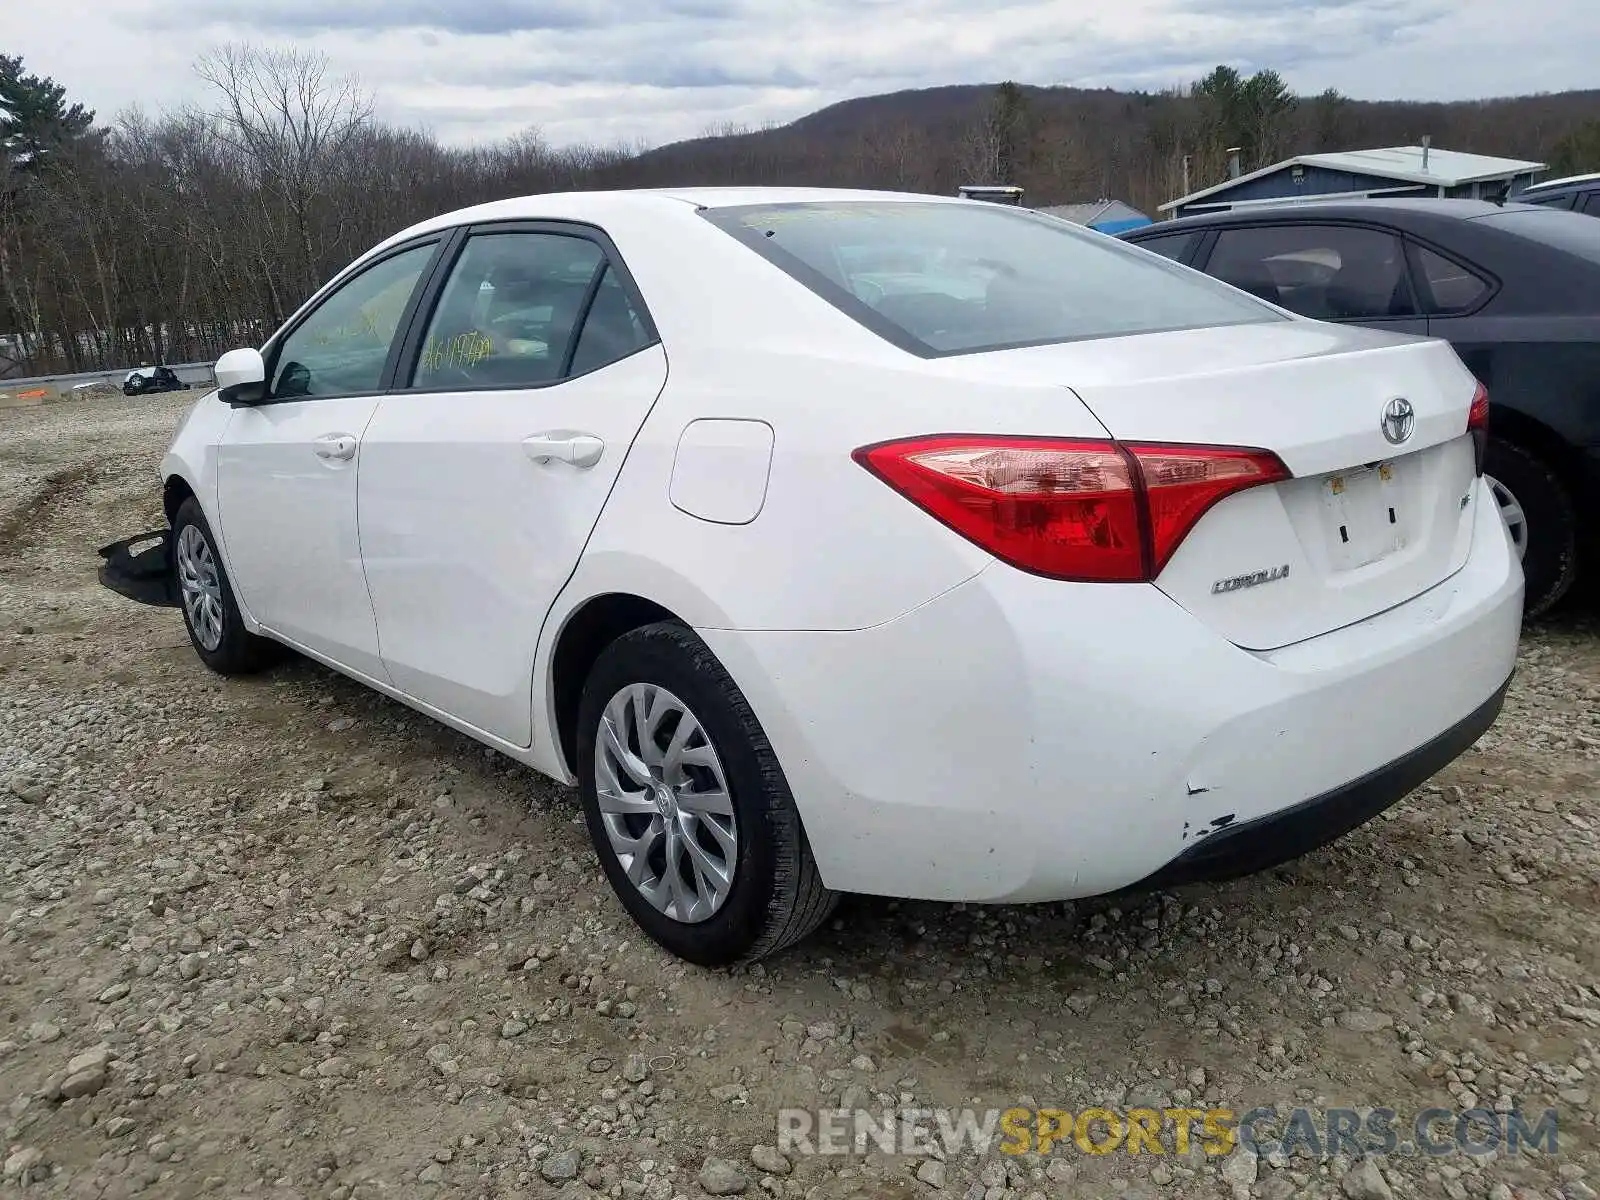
[{"x1": 854, "y1": 434, "x2": 1290, "y2": 582}]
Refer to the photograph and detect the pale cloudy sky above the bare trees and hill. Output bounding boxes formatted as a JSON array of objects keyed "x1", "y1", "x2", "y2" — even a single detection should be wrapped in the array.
[{"x1": 12, "y1": 0, "x2": 1600, "y2": 144}]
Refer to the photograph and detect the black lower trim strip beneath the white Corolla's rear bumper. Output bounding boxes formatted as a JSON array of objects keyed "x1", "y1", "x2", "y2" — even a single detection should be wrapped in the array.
[{"x1": 1126, "y1": 678, "x2": 1510, "y2": 891}]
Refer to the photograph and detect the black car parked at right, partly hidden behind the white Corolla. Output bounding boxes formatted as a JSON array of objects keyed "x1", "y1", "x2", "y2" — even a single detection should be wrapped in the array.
[{"x1": 1122, "y1": 200, "x2": 1600, "y2": 616}]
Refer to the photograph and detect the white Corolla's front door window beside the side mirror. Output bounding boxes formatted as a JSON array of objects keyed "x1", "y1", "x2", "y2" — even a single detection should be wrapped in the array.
[{"x1": 272, "y1": 242, "x2": 435, "y2": 400}]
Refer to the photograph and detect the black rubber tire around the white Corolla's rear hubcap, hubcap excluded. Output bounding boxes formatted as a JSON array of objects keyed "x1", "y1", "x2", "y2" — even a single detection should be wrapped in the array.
[{"x1": 576, "y1": 624, "x2": 803, "y2": 966}]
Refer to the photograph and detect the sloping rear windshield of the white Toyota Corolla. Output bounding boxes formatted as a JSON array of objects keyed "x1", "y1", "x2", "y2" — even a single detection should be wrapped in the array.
[{"x1": 702, "y1": 200, "x2": 1286, "y2": 357}]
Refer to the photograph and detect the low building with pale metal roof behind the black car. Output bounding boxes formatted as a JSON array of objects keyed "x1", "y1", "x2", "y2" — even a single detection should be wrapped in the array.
[{"x1": 1158, "y1": 141, "x2": 1544, "y2": 216}]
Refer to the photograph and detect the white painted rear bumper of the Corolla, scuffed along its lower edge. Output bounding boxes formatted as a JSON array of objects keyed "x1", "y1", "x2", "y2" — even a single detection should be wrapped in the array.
[{"x1": 702, "y1": 473, "x2": 1522, "y2": 901}]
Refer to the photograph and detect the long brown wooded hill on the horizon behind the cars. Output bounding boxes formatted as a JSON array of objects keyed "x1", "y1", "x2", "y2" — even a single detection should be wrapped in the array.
[{"x1": 605, "y1": 80, "x2": 1600, "y2": 211}]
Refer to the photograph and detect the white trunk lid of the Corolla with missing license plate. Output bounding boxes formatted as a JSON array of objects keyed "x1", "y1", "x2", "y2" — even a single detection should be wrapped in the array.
[{"x1": 940, "y1": 320, "x2": 1477, "y2": 650}]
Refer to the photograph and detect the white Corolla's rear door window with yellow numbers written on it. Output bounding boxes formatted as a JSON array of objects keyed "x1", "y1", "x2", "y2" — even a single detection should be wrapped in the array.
[{"x1": 411, "y1": 232, "x2": 605, "y2": 389}]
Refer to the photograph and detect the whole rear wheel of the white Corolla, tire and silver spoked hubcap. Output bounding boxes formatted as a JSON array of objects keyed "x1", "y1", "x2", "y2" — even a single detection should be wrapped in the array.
[{"x1": 578, "y1": 622, "x2": 838, "y2": 966}]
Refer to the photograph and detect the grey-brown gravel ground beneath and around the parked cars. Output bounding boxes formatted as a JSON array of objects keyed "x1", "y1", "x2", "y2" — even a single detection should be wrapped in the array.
[{"x1": 0, "y1": 394, "x2": 1600, "y2": 1200}]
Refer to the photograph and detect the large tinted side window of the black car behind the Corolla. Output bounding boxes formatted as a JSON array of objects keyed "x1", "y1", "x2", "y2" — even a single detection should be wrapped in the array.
[{"x1": 1205, "y1": 224, "x2": 1416, "y2": 320}]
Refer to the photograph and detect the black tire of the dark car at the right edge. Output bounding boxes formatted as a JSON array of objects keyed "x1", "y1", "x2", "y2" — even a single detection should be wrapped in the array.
[{"x1": 1483, "y1": 437, "x2": 1578, "y2": 618}]
